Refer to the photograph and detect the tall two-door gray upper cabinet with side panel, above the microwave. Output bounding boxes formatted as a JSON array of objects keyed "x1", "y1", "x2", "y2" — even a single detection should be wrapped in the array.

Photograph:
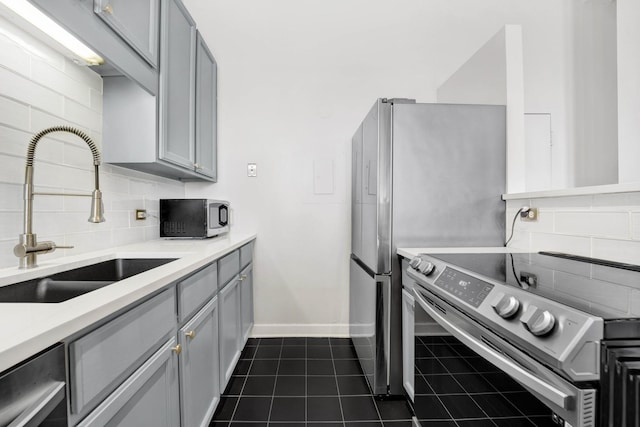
[{"x1": 101, "y1": 0, "x2": 217, "y2": 182}]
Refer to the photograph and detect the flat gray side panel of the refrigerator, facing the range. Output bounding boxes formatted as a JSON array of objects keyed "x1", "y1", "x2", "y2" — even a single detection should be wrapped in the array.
[{"x1": 393, "y1": 104, "x2": 506, "y2": 249}]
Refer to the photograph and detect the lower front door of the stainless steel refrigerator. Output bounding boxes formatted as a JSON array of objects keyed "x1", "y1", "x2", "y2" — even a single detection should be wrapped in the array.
[{"x1": 349, "y1": 257, "x2": 390, "y2": 395}]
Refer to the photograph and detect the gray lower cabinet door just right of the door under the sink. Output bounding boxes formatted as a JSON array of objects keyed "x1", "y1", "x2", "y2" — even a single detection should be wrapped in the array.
[{"x1": 178, "y1": 297, "x2": 220, "y2": 427}]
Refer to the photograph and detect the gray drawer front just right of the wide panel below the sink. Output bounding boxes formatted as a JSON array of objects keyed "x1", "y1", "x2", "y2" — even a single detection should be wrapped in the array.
[{"x1": 178, "y1": 262, "x2": 218, "y2": 322}]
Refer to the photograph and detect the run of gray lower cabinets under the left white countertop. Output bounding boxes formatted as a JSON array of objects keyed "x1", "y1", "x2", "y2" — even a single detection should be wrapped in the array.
[{"x1": 67, "y1": 246, "x2": 253, "y2": 427}]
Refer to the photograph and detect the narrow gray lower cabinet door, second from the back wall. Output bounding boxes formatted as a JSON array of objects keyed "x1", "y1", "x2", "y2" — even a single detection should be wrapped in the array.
[{"x1": 218, "y1": 277, "x2": 242, "y2": 391}]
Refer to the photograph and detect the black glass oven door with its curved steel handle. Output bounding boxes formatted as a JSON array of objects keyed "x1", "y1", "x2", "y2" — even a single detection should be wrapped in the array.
[{"x1": 413, "y1": 286, "x2": 597, "y2": 427}]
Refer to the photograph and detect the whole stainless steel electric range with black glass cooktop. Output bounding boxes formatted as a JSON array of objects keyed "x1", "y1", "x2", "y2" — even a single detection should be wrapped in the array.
[{"x1": 407, "y1": 252, "x2": 640, "y2": 427}]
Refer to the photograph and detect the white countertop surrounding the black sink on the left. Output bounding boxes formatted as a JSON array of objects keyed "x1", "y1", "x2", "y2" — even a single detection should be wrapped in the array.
[{"x1": 0, "y1": 233, "x2": 256, "y2": 372}]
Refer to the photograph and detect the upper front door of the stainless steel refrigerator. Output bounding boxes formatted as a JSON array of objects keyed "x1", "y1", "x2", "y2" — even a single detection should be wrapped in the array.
[{"x1": 351, "y1": 100, "x2": 391, "y2": 274}]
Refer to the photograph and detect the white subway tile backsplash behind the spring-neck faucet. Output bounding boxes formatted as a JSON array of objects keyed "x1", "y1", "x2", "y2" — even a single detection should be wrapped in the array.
[{"x1": 0, "y1": 17, "x2": 184, "y2": 268}]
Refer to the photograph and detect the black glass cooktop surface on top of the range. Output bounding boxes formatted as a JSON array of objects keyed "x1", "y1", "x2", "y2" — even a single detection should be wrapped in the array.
[{"x1": 429, "y1": 252, "x2": 640, "y2": 320}]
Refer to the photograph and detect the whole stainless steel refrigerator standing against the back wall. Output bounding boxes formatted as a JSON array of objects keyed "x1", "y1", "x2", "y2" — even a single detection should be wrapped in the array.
[{"x1": 349, "y1": 99, "x2": 506, "y2": 395}]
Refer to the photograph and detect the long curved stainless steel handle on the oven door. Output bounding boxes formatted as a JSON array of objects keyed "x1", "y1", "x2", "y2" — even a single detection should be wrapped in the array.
[{"x1": 413, "y1": 289, "x2": 572, "y2": 410}]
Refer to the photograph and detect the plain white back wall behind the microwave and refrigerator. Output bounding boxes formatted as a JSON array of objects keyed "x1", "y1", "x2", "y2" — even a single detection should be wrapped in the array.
[{"x1": 185, "y1": 0, "x2": 584, "y2": 335}]
